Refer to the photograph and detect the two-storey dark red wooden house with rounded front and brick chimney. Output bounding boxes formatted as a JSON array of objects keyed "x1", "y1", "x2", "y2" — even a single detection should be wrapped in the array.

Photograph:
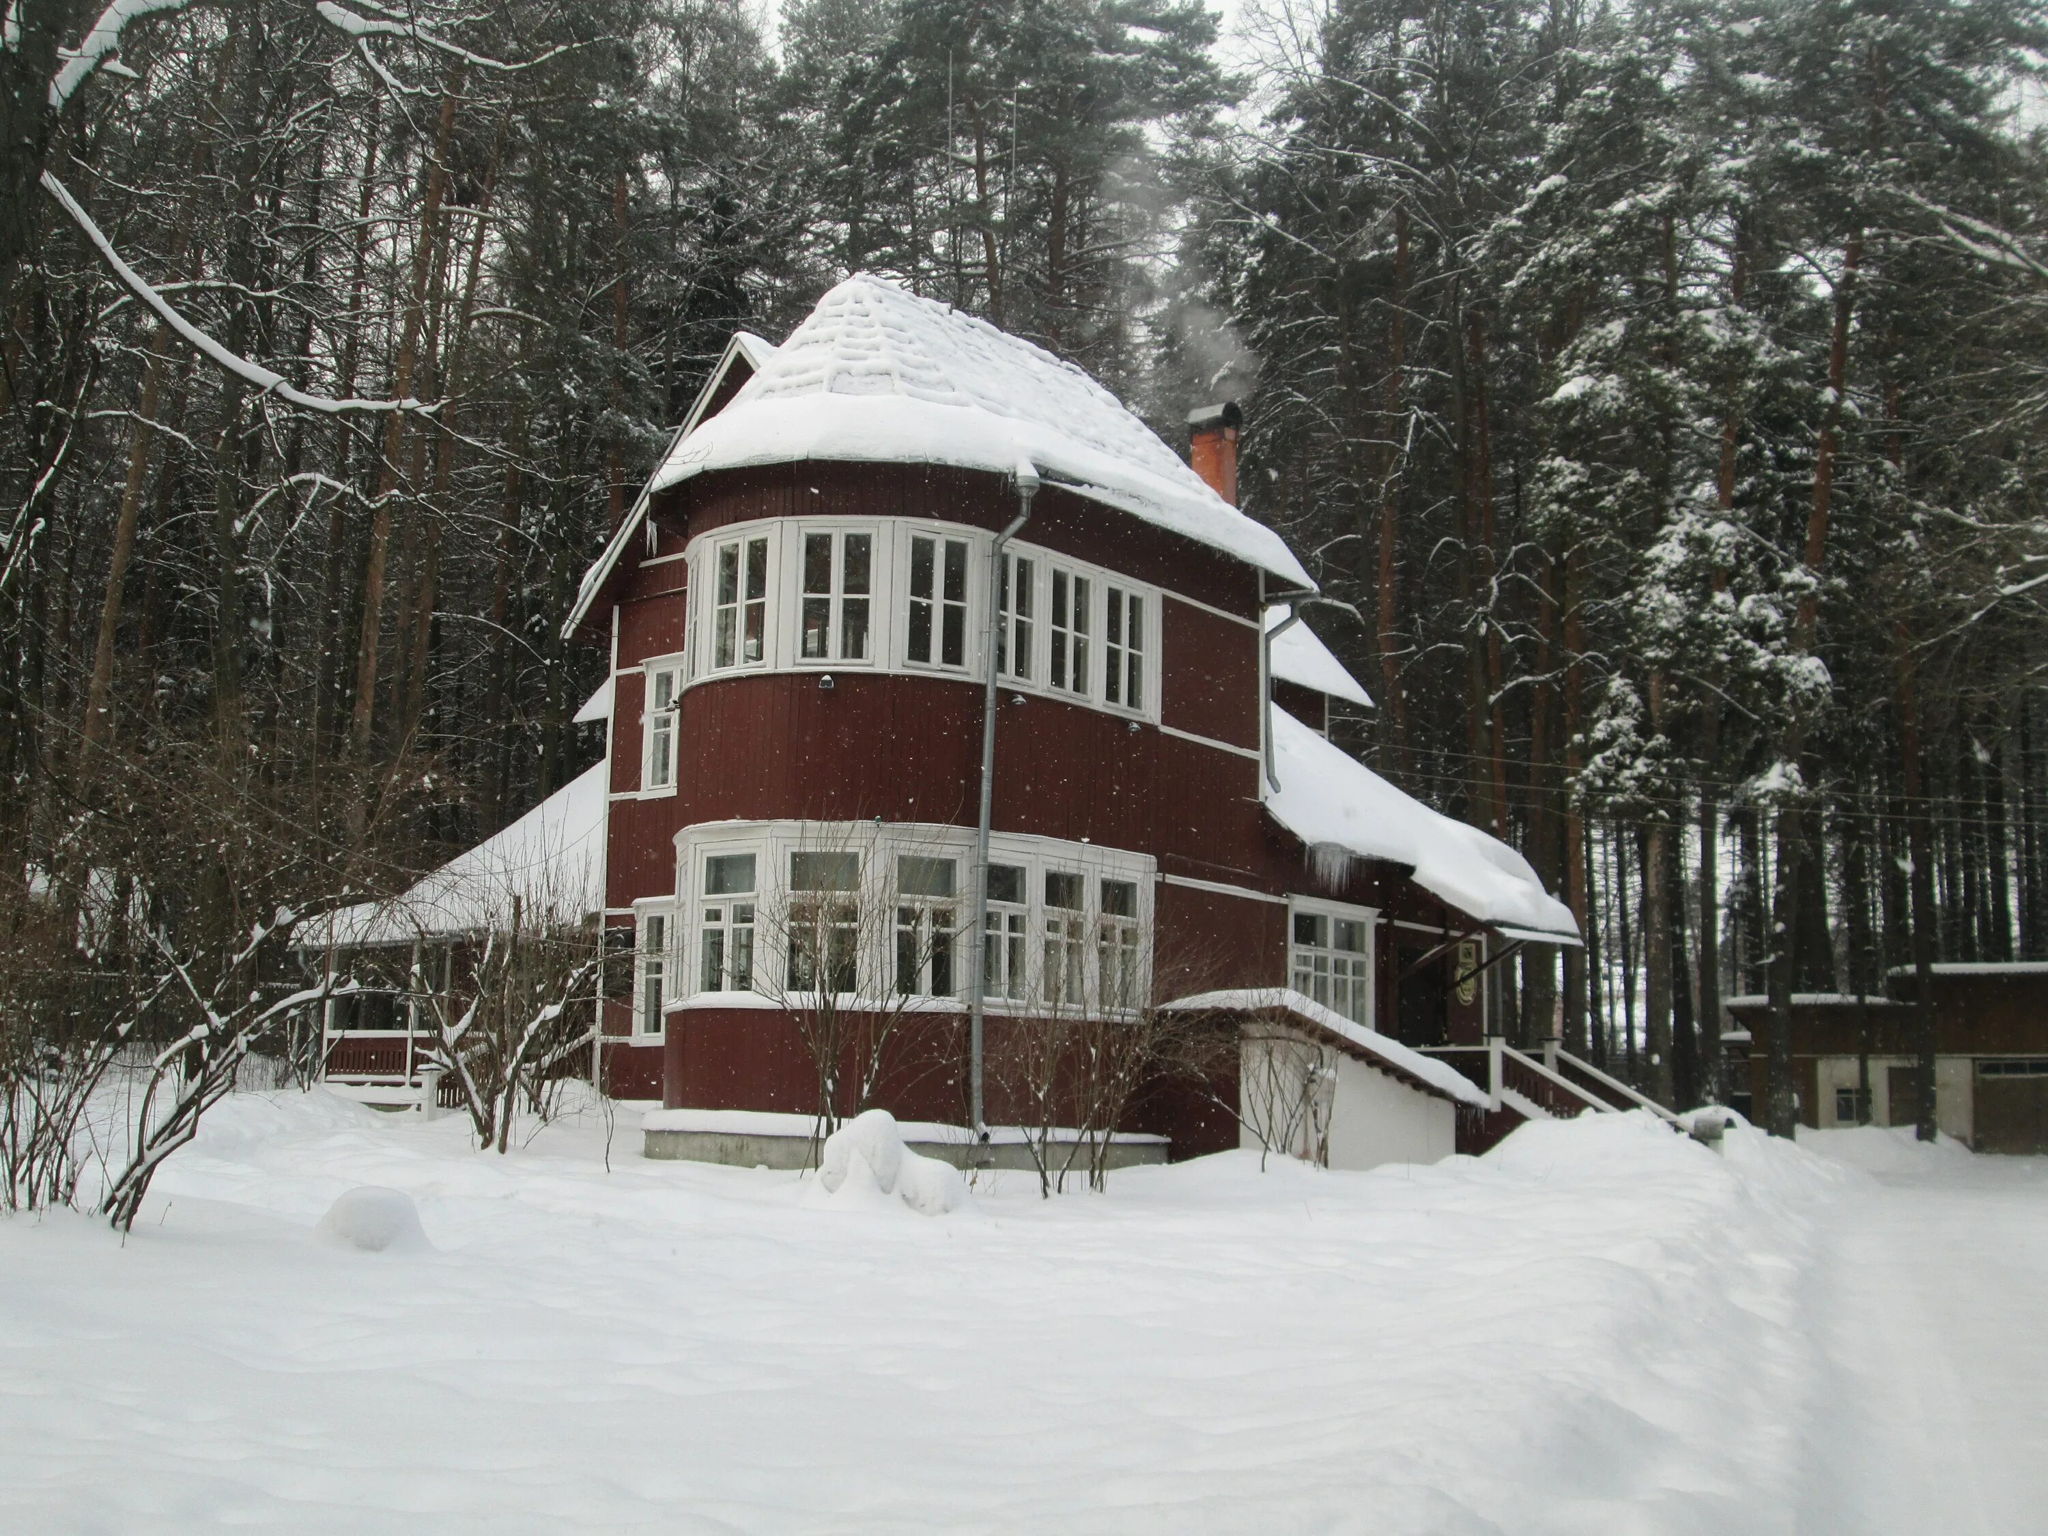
[{"x1": 536, "y1": 276, "x2": 1638, "y2": 1155}]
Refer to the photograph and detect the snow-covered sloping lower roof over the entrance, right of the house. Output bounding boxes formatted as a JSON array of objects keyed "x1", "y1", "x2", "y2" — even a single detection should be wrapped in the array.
[{"x1": 1266, "y1": 707, "x2": 1579, "y2": 944}]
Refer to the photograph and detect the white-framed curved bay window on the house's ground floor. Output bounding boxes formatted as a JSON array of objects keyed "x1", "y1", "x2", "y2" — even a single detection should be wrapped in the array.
[{"x1": 674, "y1": 821, "x2": 1153, "y2": 1012}]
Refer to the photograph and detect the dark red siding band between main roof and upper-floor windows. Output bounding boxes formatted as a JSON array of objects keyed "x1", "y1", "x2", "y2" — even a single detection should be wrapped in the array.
[{"x1": 647, "y1": 461, "x2": 1260, "y2": 618}]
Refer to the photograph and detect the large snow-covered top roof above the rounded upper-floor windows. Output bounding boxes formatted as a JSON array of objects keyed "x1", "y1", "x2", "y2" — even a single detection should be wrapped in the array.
[{"x1": 649, "y1": 272, "x2": 1315, "y2": 592}]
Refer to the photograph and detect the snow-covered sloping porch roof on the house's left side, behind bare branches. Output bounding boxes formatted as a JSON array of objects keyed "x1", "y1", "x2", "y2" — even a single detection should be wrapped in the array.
[{"x1": 315, "y1": 762, "x2": 608, "y2": 944}]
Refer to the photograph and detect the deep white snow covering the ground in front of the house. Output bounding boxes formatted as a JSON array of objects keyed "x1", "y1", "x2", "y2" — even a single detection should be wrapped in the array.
[{"x1": 0, "y1": 1094, "x2": 2048, "y2": 1536}]
